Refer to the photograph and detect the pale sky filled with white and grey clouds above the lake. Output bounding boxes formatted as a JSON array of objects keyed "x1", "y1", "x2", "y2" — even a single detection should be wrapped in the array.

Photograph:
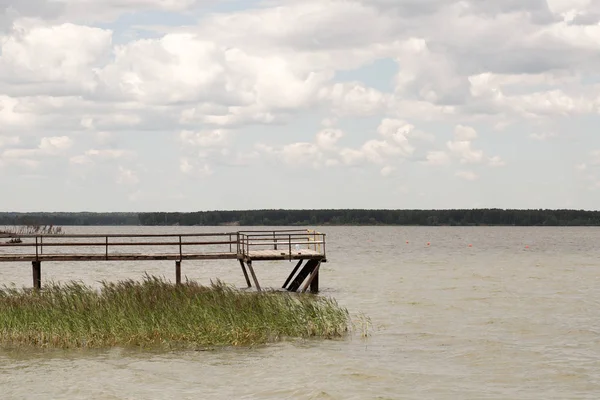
[{"x1": 0, "y1": 0, "x2": 600, "y2": 211}]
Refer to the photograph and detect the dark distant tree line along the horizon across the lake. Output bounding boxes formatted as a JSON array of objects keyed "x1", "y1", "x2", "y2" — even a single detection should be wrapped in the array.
[{"x1": 0, "y1": 209, "x2": 600, "y2": 226}]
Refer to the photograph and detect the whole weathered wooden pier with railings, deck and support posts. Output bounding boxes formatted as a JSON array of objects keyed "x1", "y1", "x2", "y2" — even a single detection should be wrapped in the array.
[{"x1": 0, "y1": 230, "x2": 327, "y2": 293}]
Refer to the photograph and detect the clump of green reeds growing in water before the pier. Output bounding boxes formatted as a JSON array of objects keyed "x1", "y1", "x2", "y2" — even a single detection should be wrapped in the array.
[{"x1": 0, "y1": 276, "x2": 350, "y2": 348}]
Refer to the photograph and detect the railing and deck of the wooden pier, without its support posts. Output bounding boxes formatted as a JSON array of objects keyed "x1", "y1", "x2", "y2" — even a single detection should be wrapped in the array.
[{"x1": 0, "y1": 229, "x2": 325, "y2": 261}]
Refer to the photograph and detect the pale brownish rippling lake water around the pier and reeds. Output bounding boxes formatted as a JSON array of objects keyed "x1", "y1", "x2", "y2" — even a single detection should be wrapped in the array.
[{"x1": 0, "y1": 227, "x2": 600, "y2": 399}]
